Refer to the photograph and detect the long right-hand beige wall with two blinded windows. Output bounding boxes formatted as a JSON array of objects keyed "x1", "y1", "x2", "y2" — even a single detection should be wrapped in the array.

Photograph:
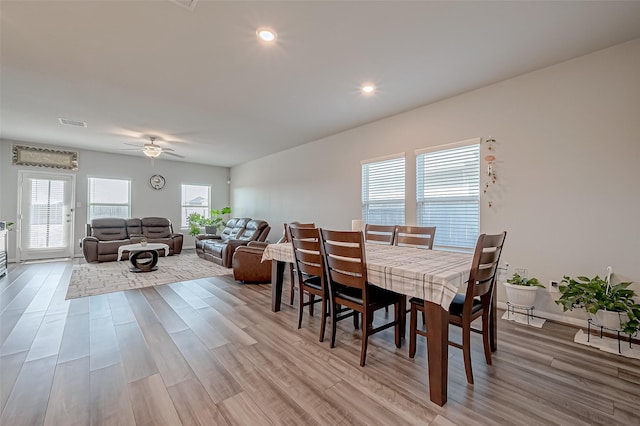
[{"x1": 231, "y1": 39, "x2": 640, "y2": 318}]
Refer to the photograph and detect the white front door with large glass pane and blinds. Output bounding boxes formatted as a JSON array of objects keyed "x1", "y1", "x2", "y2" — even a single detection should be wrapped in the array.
[{"x1": 18, "y1": 171, "x2": 75, "y2": 261}]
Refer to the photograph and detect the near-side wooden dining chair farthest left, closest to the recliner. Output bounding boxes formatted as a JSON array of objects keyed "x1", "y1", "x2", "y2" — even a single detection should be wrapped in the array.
[{"x1": 288, "y1": 225, "x2": 329, "y2": 342}]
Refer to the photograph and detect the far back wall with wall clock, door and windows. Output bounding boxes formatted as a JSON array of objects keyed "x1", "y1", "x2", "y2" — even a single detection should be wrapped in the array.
[{"x1": 0, "y1": 140, "x2": 229, "y2": 260}]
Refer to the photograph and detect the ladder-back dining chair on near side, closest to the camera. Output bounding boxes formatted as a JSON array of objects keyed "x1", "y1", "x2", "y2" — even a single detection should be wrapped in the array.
[{"x1": 320, "y1": 229, "x2": 406, "y2": 366}]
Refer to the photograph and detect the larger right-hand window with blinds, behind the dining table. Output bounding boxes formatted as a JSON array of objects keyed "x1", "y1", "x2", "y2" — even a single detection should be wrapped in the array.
[{"x1": 416, "y1": 139, "x2": 480, "y2": 249}]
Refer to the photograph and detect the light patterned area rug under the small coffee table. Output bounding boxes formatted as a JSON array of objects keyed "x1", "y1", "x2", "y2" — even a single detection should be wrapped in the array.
[{"x1": 66, "y1": 253, "x2": 232, "y2": 299}]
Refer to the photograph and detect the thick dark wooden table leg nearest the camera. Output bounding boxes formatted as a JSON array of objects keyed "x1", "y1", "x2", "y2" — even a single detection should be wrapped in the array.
[{"x1": 424, "y1": 300, "x2": 449, "y2": 407}]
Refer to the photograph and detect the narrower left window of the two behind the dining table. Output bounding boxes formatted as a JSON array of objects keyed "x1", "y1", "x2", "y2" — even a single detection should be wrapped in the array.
[{"x1": 362, "y1": 154, "x2": 405, "y2": 225}]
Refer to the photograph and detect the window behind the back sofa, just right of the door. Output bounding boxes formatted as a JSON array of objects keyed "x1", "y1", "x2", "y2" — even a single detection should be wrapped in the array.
[{"x1": 88, "y1": 178, "x2": 131, "y2": 222}]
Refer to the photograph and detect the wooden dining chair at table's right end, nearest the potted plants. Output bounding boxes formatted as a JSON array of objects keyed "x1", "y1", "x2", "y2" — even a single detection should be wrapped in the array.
[{"x1": 409, "y1": 232, "x2": 507, "y2": 384}]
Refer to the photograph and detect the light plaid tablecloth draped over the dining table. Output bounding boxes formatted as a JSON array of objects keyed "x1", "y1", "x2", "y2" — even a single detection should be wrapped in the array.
[{"x1": 262, "y1": 243, "x2": 473, "y2": 309}]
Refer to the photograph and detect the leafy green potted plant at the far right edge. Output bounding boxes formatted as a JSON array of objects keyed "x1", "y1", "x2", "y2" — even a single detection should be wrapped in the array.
[{"x1": 556, "y1": 275, "x2": 640, "y2": 335}]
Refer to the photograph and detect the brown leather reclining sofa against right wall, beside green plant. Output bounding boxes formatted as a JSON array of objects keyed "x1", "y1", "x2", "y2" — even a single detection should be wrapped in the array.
[{"x1": 196, "y1": 218, "x2": 271, "y2": 268}]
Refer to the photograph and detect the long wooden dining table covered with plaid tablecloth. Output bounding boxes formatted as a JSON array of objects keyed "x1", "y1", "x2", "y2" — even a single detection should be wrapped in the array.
[{"x1": 262, "y1": 242, "x2": 497, "y2": 406}]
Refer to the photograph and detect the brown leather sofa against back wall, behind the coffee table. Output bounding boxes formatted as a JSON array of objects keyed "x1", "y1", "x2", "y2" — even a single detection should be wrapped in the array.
[{"x1": 82, "y1": 217, "x2": 183, "y2": 262}]
